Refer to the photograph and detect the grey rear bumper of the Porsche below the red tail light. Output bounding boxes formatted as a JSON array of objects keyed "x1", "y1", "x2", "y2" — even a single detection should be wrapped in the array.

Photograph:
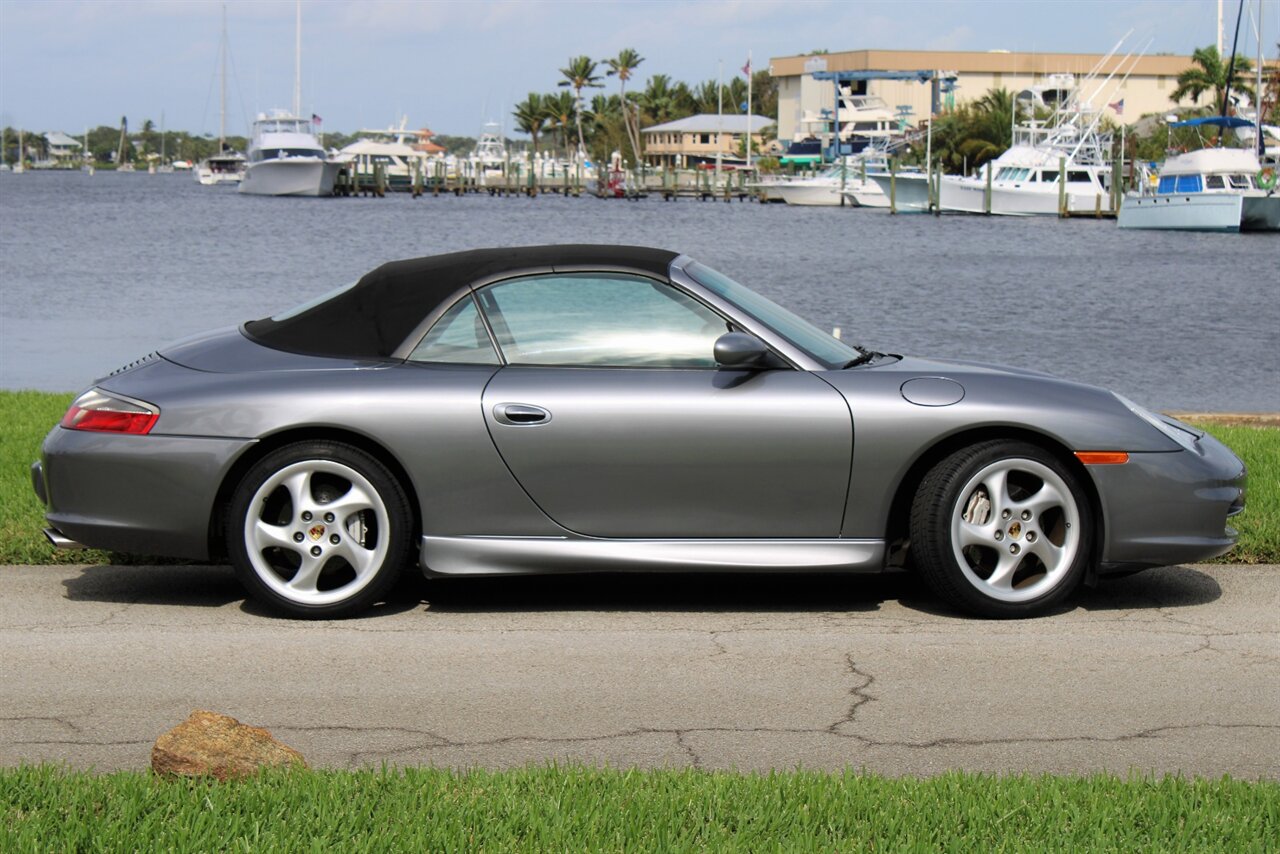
[{"x1": 31, "y1": 428, "x2": 252, "y2": 560}]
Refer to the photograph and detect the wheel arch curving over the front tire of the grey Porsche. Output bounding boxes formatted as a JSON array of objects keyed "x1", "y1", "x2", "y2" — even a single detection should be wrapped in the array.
[{"x1": 884, "y1": 426, "x2": 1106, "y2": 573}]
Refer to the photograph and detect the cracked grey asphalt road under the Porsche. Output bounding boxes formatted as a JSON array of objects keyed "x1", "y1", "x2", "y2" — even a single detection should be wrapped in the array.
[{"x1": 0, "y1": 566, "x2": 1280, "y2": 778}]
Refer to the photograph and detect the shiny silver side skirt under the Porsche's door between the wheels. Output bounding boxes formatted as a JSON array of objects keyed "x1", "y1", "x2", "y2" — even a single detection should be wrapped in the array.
[{"x1": 421, "y1": 536, "x2": 884, "y2": 576}]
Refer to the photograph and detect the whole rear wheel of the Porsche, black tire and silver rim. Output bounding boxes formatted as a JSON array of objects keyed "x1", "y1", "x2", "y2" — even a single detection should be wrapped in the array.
[{"x1": 227, "y1": 440, "x2": 413, "y2": 620}]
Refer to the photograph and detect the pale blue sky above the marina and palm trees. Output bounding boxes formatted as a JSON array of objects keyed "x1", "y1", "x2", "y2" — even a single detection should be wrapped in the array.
[{"x1": 0, "y1": 0, "x2": 1280, "y2": 136}]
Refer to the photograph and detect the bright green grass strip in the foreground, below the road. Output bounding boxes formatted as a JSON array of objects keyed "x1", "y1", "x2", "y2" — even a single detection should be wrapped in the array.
[{"x1": 0, "y1": 766, "x2": 1280, "y2": 854}]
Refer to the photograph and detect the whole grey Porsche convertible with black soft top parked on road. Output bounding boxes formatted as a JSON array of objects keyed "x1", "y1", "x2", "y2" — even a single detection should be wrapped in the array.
[{"x1": 32, "y1": 246, "x2": 1245, "y2": 617}]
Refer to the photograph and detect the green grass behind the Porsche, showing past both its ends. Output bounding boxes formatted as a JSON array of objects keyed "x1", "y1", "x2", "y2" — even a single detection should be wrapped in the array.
[{"x1": 0, "y1": 392, "x2": 1280, "y2": 563}]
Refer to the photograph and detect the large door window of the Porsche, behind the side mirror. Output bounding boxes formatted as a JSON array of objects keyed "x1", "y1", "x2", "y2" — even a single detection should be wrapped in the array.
[{"x1": 477, "y1": 273, "x2": 728, "y2": 369}]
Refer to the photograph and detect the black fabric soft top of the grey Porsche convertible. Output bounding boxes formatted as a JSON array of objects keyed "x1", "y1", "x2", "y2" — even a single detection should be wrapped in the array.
[{"x1": 244, "y1": 245, "x2": 678, "y2": 359}]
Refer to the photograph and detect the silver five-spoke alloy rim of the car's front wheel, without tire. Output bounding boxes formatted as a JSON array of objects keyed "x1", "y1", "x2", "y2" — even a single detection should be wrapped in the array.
[{"x1": 951, "y1": 458, "x2": 1083, "y2": 602}]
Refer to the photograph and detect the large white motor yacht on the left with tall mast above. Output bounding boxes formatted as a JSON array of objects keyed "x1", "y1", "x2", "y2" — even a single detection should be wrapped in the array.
[{"x1": 239, "y1": 0, "x2": 343, "y2": 196}]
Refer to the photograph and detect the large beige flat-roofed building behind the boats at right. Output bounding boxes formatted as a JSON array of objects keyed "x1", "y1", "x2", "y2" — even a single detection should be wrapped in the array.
[{"x1": 769, "y1": 50, "x2": 1269, "y2": 141}]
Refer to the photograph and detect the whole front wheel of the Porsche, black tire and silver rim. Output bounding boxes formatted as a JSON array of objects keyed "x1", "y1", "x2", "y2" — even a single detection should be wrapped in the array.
[{"x1": 910, "y1": 440, "x2": 1094, "y2": 618}]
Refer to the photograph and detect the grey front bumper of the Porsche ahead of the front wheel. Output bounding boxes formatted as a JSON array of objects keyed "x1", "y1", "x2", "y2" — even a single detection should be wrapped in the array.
[{"x1": 1088, "y1": 434, "x2": 1247, "y2": 572}]
